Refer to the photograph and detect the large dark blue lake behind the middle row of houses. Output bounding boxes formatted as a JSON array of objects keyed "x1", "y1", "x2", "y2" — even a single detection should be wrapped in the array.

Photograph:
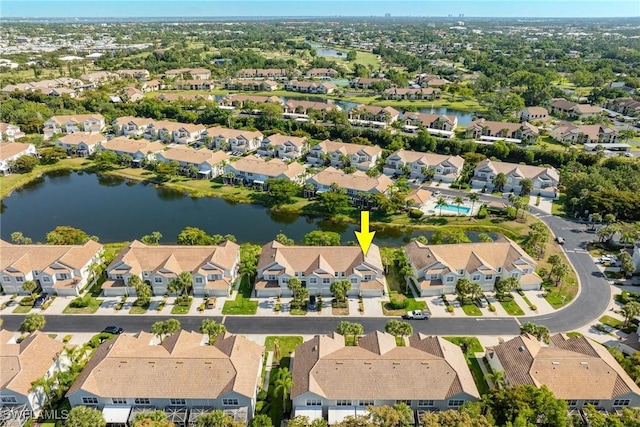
[{"x1": 0, "y1": 171, "x2": 496, "y2": 246}]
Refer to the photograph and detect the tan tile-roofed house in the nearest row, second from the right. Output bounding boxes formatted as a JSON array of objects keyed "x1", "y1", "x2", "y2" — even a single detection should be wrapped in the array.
[{"x1": 291, "y1": 331, "x2": 480, "y2": 425}]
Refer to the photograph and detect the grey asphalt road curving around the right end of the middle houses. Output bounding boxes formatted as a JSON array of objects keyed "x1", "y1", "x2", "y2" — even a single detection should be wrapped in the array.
[{"x1": 2, "y1": 189, "x2": 611, "y2": 335}]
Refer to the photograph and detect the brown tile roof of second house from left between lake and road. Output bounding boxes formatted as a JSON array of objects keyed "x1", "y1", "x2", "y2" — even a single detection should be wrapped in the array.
[{"x1": 107, "y1": 240, "x2": 240, "y2": 275}]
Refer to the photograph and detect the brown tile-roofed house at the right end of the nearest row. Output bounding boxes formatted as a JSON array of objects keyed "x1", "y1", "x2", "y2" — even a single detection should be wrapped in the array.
[{"x1": 487, "y1": 334, "x2": 640, "y2": 411}]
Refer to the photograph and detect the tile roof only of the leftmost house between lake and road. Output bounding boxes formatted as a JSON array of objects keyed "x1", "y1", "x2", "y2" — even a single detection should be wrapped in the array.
[{"x1": 0, "y1": 240, "x2": 102, "y2": 273}]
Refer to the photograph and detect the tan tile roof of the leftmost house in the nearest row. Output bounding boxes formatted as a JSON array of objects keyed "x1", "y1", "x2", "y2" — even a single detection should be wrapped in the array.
[{"x1": 0, "y1": 330, "x2": 64, "y2": 396}]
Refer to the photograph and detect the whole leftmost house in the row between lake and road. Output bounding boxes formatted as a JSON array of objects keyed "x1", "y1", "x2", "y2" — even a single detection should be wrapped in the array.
[{"x1": 0, "y1": 240, "x2": 102, "y2": 296}]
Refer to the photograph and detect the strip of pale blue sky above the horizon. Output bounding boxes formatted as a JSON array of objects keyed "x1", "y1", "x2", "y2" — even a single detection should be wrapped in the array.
[{"x1": 0, "y1": 0, "x2": 640, "y2": 18}]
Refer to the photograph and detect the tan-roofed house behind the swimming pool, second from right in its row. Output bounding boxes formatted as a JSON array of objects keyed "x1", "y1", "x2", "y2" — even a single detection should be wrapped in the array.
[{"x1": 383, "y1": 150, "x2": 464, "y2": 182}]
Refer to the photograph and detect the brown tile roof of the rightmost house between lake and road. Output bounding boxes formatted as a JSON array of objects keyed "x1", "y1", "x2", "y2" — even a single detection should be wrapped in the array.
[{"x1": 404, "y1": 237, "x2": 536, "y2": 273}]
